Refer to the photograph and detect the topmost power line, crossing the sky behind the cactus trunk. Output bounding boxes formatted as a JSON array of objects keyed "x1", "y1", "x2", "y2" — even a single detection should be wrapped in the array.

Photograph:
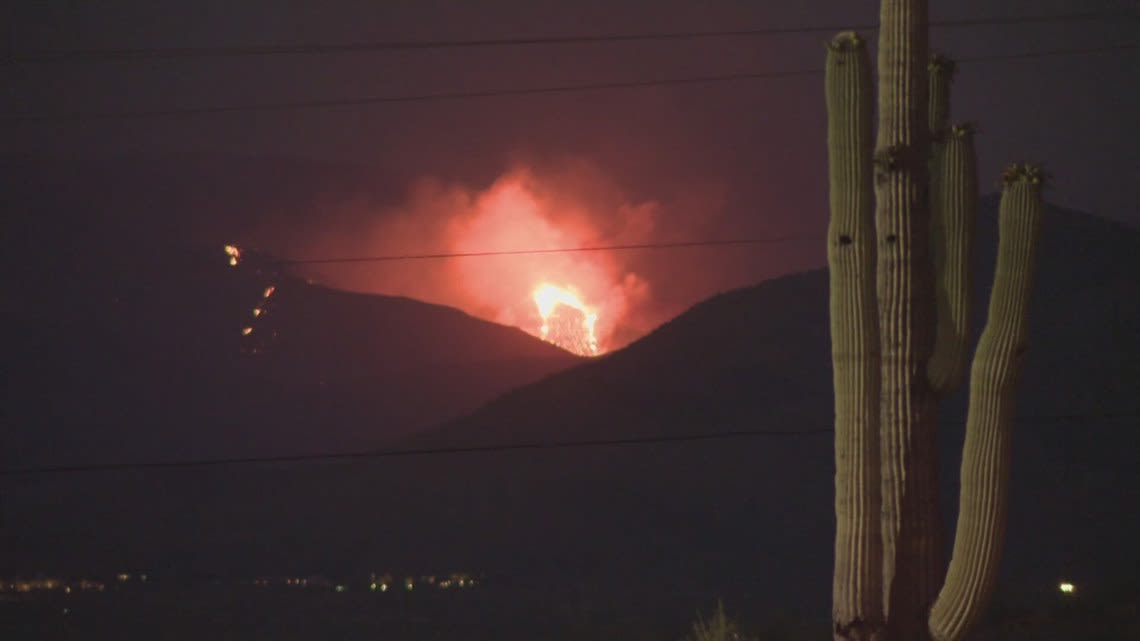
[{"x1": 0, "y1": 10, "x2": 1135, "y2": 64}]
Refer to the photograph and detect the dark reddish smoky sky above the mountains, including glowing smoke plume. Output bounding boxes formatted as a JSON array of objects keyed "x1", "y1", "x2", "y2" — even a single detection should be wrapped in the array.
[{"x1": 0, "y1": 0, "x2": 1140, "y2": 348}]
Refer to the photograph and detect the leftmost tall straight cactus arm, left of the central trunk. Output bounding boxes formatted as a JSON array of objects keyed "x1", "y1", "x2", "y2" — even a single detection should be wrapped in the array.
[{"x1": 824, "y1": 32, "x2": 884, "y2": 641}]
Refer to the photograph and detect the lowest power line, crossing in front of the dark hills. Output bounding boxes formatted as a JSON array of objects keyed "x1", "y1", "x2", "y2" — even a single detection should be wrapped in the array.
[{"x1": 0, "y1": 413, "x2": 1140, "y2": 478}]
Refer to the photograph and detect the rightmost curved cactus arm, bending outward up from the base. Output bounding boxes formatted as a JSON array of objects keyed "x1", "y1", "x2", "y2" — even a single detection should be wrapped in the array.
[{"x1": 929, "y1": 165, "x2": 1042, "y2": 641}]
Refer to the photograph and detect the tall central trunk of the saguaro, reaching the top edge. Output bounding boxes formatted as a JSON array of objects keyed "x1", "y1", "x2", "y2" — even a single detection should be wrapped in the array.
[{"x1": 876, "y1": 0, "x2": 945, "y2": 640}]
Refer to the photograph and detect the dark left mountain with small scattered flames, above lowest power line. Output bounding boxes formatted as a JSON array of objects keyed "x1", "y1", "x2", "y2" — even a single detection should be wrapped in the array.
[{"x1": 5, "y1": 244, "x2": 577, "y2": 466}]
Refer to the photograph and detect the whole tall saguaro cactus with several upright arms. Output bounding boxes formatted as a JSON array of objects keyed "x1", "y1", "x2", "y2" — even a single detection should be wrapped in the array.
[{"x1": 825, "y1": 0, "x2": 1042, "y2": 641}]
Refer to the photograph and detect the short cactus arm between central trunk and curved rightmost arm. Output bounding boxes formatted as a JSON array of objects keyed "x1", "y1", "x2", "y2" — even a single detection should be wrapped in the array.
[{"x1": 927, "y1": 124, "x2": 978, "y2": 387}]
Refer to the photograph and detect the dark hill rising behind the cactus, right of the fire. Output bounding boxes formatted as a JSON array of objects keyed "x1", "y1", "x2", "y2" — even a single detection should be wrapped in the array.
[{"x1": 376, "y1": 197, "x2": 1140, "y2": 611}]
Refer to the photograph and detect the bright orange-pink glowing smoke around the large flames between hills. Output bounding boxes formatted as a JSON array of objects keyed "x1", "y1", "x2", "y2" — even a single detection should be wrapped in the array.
[{"x1": 441, "y1": 171, "x2": 649, "y2": 356}]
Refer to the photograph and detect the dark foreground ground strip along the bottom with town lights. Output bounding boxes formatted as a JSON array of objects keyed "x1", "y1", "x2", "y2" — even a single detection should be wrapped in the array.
[{"x1": 0, "y1": 574, "x2": 1140, "y2": 641}]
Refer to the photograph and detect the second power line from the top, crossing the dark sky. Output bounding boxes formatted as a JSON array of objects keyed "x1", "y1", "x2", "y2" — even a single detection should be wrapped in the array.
[{"x1": 0, "y1": 43, "x2": 1140, "y2": 122}]
